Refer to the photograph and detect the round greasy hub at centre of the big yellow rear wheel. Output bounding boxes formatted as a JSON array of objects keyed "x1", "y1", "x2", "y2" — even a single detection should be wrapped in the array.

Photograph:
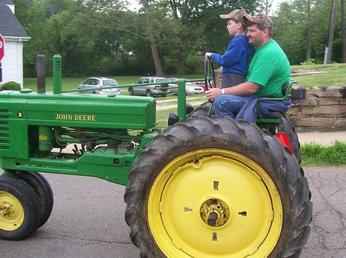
[{"x1": 200, "y1": 198, "x2": 230, "y2": 228}]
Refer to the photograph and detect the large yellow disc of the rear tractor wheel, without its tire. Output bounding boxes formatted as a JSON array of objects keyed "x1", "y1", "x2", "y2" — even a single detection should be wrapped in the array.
[{"x1": 147, "y1": 148, "x2": 283, "y2": 258}]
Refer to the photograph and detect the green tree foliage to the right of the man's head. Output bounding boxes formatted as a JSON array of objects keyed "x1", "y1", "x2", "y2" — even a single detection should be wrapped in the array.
[{"x1": 274, "y1": 0, "x2": 342, "y2": 64}]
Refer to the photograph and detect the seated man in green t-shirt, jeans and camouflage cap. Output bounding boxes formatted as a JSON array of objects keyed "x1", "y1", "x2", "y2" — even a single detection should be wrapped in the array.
[{"x1": 207, "y1": 15, "x2": 291, "y2": 122}]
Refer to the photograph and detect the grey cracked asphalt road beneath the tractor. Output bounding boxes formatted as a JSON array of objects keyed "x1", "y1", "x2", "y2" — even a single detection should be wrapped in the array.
[{"x1": 0, "y1": 167, "x2": 346, "y2": 258}]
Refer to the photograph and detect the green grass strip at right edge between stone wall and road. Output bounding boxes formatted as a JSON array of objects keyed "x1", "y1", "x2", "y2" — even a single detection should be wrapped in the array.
[{"x1": 301, "y1": 142, "x2": 346, "y2": 166}]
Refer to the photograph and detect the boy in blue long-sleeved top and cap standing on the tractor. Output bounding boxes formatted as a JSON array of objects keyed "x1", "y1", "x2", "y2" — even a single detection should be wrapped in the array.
[{"x1": 206, "y1": 9, "x2": 254, "y2": 88}]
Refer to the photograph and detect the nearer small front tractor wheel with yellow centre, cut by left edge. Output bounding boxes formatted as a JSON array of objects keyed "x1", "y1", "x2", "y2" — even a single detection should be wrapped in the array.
[{"x1": 0, "y1": 176, "x2": 39, "y2": 240}]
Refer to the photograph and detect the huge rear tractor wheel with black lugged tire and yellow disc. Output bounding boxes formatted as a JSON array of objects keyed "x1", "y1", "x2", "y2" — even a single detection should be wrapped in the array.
[{"x1": 125, "y1": 117, "x2": 312, "y2": 258}]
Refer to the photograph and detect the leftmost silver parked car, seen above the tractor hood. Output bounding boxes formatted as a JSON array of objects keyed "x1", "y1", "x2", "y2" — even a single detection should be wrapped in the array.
[{"x1": 78, "y1": 77, "x2": 120, "y2": 95}]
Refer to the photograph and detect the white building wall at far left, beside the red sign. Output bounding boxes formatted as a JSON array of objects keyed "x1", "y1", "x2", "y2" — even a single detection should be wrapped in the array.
[{"x1": 2, "y1": 40, "x2": 23, "y2": 86}]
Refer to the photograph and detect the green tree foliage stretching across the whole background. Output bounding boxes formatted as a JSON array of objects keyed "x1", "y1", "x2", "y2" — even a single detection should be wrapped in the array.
[{"x1": 14, "y1": 0, "x2": 343, "y2": 76}]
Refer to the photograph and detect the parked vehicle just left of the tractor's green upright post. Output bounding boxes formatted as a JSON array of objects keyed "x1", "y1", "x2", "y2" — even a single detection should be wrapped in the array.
[{"x1": 128, "y1": 77, "x2": 168, "y2": 97}]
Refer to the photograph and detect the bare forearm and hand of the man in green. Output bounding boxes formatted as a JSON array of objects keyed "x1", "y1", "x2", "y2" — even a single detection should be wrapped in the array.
[{"x1": 206, "y1": 82, "x2": 259, "y2": 99}]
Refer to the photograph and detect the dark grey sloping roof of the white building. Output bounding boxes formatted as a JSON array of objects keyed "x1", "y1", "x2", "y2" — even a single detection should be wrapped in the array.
[{"x1": 0, "y1": 4, "x2": 28, "y2": 38}]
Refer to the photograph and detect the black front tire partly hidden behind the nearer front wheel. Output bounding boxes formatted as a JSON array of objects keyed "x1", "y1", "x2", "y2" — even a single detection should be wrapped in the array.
[{"x1": 5, "y1": 171, "x2": 54, "y2": 227}]
